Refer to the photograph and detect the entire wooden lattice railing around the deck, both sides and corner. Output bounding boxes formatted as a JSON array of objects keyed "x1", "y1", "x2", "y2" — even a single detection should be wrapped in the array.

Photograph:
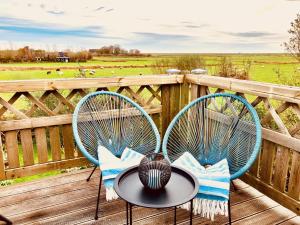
[{"x1": 0, "y1": 75, "x2": 300, "y2": 214}]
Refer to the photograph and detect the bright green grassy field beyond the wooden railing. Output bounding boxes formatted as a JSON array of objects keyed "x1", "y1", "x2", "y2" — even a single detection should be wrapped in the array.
[{"x1": 0, "y1": 54, "x2": 300, "y2": 83}]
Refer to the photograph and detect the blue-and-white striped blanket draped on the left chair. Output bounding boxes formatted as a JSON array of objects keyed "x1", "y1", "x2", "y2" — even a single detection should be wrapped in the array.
[{"x1": 98, "y1": 145, "x2": 144, "y2": 201}]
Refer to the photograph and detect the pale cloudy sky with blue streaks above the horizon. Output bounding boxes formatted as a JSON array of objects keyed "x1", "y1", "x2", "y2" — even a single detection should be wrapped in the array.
[{"x1": 0, "y1": 0, "x2": 300, "y2": 53}]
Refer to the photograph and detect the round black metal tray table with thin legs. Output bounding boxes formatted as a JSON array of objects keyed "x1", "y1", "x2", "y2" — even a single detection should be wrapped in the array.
[{"x1": 114, "y1": 166, "x2": 199, "y2": 224}]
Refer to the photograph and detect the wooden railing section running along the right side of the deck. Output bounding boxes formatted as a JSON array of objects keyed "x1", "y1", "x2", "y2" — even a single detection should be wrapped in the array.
[{"x1": 185, "y1": 75, "x2": 300, "y2": 214}]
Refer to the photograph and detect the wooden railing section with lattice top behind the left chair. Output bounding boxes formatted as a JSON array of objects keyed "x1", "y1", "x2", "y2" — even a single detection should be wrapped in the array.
[{"x1": 0, "y1": 76, "x2": 183, "y2": 180}]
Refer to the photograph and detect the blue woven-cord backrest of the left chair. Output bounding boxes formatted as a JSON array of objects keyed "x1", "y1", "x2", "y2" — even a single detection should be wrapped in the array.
[{"x1": 72, "y1": 91, "x2": 160, "y2": 165}]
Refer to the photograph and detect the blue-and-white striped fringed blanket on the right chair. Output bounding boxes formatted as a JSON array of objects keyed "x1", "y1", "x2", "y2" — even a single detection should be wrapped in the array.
[{"x1": 172, "y1": 152, "x2": 230, "y2": 221}]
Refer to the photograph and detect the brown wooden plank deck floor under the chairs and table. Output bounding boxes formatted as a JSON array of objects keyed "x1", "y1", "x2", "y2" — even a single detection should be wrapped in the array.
[{"x1": 0, "y1": 169, "x2": 300, "y2": 225}]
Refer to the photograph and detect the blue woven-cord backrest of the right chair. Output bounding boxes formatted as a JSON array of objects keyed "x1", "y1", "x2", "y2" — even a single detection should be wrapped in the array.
[{"x1": 162, "y1": 93, "x2": 261, "y2": 179}]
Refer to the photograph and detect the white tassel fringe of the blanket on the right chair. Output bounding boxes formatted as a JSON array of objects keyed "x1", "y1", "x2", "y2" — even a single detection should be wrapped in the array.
[{"x1": 179, "y1": 198, "x2": 228, "y2": 221}]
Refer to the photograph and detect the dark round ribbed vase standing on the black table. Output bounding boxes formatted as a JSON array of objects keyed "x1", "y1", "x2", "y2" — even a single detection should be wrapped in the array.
[{"x1": 138, "y1": 153, "x2": 171, "y2": 190}]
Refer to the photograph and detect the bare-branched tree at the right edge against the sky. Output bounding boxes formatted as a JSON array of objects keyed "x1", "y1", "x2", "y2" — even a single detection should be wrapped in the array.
[{"x1": 283, "y1": 14, "x2": 300, "y2": 62}]
